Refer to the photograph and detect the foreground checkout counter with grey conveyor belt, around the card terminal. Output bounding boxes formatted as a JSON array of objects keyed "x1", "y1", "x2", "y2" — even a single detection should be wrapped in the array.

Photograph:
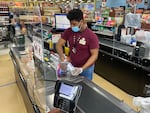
[{"x1": 10, "y1": 47, "x2": 136, "y2": 113}]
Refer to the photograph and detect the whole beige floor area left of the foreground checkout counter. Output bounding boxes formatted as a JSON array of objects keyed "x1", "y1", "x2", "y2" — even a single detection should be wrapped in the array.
[{"x1": 0, "y1": 52, "x2": 27, "y2": 113}]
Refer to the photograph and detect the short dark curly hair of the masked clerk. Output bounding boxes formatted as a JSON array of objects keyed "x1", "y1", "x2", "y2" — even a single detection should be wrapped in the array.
[{"x1": 67, "y1": 9, "x2": 83, "y2": 21}]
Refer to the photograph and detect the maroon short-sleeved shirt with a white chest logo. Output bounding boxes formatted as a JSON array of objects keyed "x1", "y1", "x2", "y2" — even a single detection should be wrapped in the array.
[{"x1": 62, "y1": 28, "x2": 99, "y2": 67}]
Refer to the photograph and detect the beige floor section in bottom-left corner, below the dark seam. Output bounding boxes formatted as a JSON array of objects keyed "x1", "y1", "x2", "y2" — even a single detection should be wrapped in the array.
[{"x1": 0, "y1": 83, "x2": 27, "y2": 113}]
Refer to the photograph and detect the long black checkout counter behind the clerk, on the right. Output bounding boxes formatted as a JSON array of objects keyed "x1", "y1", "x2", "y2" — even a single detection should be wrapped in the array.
[{"x1": 95, "y1": 35, "x2": 150, "y2": 96}]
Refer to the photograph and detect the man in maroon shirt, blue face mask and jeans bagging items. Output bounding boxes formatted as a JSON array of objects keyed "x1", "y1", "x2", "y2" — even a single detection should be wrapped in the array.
[{"x1": 56, "y1": 9, "x2": 99, "y2": 80}]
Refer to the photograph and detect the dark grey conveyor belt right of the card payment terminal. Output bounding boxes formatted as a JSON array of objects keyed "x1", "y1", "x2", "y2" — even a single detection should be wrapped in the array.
[{"x1": 78, "y1": 82, "x2": 135, "y2": 113}]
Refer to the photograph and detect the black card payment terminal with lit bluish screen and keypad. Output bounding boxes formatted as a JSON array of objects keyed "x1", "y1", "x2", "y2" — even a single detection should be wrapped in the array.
[{"x1": 54, "y1": 80, "x2": 82, "y2": 113}]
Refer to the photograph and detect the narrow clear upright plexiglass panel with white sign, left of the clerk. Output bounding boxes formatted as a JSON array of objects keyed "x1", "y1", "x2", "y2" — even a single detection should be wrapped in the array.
[{"x1": 31, "y1": 6, "x2": 47, "y2": 113}]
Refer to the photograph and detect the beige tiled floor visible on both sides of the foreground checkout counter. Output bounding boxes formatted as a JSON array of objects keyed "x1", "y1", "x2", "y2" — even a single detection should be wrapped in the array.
[{"x1": 0, "y1": 49, "x2": 137, "y2": 113}]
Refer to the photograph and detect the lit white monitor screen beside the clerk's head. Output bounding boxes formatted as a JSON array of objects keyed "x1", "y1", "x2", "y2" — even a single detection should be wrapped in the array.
[{"x1": 55, "y1": 14, "x2": 70, "y2": 30}]
